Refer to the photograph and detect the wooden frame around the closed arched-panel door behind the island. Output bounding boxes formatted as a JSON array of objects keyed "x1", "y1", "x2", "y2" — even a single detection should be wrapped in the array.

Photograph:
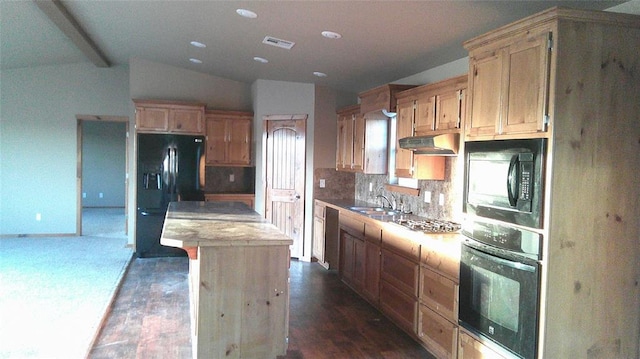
[{"x1": 262, "y1": 114, "x2": 310, "y2": 260}]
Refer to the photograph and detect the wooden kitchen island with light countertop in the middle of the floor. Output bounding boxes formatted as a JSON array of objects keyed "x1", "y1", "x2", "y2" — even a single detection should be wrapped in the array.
[{"x1": 160, "y1": 202, "x2": 293, "y2": 358}]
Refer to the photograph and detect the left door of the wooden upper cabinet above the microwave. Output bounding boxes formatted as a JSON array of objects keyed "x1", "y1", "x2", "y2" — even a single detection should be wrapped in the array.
[{"x1": 465, "y1": 49, "x2": 506, "y2": 138}]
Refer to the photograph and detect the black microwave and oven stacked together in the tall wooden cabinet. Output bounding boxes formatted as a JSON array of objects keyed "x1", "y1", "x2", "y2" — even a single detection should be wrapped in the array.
[{"x1": 459, "y1": 139, "x2": 547, "y2": 359}]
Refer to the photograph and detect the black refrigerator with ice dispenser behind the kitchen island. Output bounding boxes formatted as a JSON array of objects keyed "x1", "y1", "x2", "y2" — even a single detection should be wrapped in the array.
[{"x1": 136, "y1": 134, "x2": 205, "y2": 258}]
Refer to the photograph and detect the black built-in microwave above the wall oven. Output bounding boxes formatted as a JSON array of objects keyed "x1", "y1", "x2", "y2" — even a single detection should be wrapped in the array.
[{"x1": 464, "y1": 139, "x2": 547, "y2": 228}]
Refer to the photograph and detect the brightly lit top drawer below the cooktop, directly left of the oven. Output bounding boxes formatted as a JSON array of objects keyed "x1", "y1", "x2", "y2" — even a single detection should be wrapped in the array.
[{"x1": 420, "y1": 240, "x2": 460, "y2": 281}]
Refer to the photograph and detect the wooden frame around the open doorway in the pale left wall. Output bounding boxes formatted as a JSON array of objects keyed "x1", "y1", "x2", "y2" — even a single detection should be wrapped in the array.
[{"x1": 76, "y1": 115, "x2": 129, "y2": 236}]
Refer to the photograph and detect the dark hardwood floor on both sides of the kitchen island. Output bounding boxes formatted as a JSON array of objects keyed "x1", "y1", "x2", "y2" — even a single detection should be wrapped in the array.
[{"x1": 89, "y1": 258, "x2": 433, "y2": 359}]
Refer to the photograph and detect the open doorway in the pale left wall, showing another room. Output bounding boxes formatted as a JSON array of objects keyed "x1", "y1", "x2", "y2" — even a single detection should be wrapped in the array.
[{"x1": 76, "y1": 115, "x2": 129, "y2": 236}]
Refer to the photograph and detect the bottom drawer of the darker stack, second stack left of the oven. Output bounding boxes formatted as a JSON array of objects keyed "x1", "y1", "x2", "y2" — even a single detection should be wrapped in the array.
[{"x1": 380, "y1": 280, "x2": 418, "y2": 333}]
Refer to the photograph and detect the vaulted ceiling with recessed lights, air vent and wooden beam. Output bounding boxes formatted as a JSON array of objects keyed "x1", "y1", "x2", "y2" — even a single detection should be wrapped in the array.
[{"x1": 0, "y1": 0, "x2": 640, "y2": 92}]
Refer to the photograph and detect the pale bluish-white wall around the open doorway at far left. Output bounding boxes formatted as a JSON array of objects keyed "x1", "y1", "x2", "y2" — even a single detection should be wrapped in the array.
[{"x1": 0, "y1": 63, "x2": 131, "y2": 235}]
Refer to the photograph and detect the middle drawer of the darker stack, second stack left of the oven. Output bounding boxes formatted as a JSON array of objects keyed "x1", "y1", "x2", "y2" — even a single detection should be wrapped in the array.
[{"x1": 380, "y1": 249, "x2": 419, "y2": 297}]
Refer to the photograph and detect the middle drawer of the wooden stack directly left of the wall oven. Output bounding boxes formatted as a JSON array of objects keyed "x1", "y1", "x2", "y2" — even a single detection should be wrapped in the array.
[{"x1": 418, "y1": 266, "x2": 458, "y2": 323}]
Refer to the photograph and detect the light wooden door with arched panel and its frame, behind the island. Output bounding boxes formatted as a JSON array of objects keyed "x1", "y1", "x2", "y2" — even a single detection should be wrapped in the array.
[{"x1": 264, "y1": 115, "x2": 307, "y2": 258}]
